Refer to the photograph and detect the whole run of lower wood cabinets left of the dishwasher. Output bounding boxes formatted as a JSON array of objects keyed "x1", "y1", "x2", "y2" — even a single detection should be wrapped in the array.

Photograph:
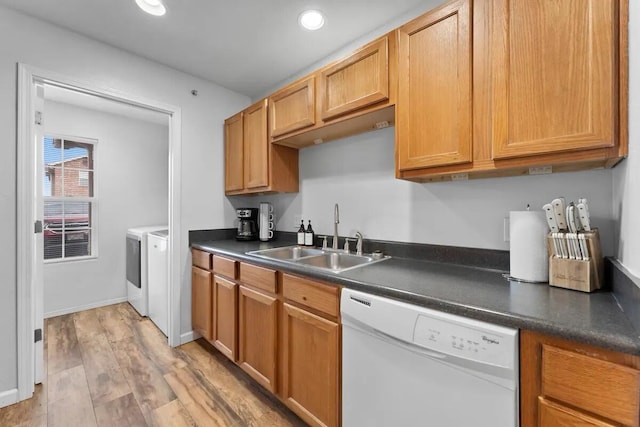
[{"x1": 192, "y1": 254, "x2": 342, "y2": 427}]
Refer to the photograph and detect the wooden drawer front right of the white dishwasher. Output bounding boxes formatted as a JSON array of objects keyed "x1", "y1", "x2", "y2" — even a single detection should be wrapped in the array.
[{"x1": 542, "y1": 345, "x2": 640, "y2": 425}]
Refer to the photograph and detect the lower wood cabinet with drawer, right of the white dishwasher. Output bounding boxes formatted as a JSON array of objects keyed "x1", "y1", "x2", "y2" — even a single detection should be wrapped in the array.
[{"x1": 520, "y1": 331, "x2": 640, "y2": 427}]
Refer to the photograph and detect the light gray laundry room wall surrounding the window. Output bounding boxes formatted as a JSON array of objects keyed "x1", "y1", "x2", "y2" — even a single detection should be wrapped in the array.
[{"x1": 43, "y1": 101, "x2": 169, "y2": 317}]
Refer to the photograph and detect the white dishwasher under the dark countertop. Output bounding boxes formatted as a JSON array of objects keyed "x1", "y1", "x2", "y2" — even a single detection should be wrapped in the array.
[{"x1": 341, "y1": 289, "x2": 519, "y2": 427}]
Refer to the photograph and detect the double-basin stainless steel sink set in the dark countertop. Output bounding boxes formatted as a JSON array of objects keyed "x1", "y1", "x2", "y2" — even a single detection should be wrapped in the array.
[{"x1": 247, "y1": 246, "x2": 390, "y2": 273}]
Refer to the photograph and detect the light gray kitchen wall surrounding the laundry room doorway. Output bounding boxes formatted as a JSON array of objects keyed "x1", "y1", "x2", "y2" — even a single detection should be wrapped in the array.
[{"x1": 0, "y1": 7, "x2": 250, "y2": 393}]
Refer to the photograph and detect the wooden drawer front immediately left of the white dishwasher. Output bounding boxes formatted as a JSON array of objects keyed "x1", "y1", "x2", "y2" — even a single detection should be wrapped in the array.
[{"x1": 282, "y1": 274, "x2": 340, "y2": 317}]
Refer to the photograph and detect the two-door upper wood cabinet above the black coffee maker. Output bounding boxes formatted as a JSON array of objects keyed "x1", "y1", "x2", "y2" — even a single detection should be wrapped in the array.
[{"x1": 225, "y1": 99, "x2": 298, "y2": 195}]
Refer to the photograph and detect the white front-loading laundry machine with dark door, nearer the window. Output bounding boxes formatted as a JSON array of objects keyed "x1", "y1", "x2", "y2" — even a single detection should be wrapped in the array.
[{"x1": 126, "y1": 225, "x2": 167, "y2": 316}]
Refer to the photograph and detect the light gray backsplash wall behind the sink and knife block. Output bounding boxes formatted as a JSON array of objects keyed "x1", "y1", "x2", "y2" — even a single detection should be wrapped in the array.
[{"x1": 229, "y1": 128, "x2": 614, "y2": 255}]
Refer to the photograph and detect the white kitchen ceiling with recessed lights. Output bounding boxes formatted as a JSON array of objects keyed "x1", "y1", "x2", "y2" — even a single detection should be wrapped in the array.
[{"x1": 0, "y1": 0, "x2": 434, "y2": 98}]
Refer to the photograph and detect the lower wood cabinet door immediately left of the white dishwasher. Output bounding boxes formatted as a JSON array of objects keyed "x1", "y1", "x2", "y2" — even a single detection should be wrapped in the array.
[{"x1": 281, "y1": 303, "x2": 341, "y2": 426}]
